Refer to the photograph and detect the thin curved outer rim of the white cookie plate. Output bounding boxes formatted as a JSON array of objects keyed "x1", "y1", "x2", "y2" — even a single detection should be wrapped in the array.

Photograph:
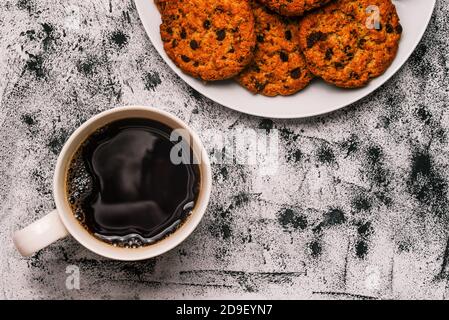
[{"x1": 134, "y1": 0, "x2": 437, "y2": 120}]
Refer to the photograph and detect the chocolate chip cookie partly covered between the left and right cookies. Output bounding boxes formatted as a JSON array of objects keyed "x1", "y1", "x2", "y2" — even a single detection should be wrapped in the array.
[{"x1": 237, "y1": 2, "x2": 313, "y2": 97}]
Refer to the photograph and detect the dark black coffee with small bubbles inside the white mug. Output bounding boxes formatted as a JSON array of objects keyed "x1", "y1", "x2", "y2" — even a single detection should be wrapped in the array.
[{"x1": 67, "y1": 119, "x2": 200, "y2": 247}]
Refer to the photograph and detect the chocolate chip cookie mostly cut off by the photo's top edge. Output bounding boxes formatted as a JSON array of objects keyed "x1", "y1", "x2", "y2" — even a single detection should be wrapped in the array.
[{"x1": 258, "y1": 0, "x2": 332, "y2": 16}]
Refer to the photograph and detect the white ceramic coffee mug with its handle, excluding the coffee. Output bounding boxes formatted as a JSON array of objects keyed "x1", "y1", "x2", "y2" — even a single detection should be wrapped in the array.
[{"x1": 13, "y1": 106, "x2": 212, "y2": 261}]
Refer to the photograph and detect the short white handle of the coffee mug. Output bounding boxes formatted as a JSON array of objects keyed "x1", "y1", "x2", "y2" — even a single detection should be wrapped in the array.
[{"x1": 13, "y1": 210, "x2": 69, "y2": 257}]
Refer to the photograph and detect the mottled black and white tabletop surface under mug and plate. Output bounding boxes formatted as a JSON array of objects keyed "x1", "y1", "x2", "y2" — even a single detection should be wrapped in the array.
[{"x1": 0, "y1": 0, "x2": 449, "y2": 299}]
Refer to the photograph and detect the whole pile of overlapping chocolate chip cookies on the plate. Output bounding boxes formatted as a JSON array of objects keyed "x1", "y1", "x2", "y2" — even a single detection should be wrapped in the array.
[{"x1": 156, "y1": 0, "x2": 402, "y2": 97}]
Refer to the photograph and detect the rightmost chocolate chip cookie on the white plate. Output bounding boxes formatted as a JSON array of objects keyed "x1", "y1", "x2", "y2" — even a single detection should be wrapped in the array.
[{"x1": 299, "y1": 0, "x2": 402, "y2": 88}]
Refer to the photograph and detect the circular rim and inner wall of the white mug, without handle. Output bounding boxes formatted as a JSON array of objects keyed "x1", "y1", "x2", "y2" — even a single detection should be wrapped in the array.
[{"x1": 53, "y1": 106, "x2": 212, "y2": 261}]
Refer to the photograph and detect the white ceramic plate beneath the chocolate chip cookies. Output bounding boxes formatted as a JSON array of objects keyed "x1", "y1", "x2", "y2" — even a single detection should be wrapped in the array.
[{"x1": 135, "y1": 0, "x2": 436, "y2": 119}]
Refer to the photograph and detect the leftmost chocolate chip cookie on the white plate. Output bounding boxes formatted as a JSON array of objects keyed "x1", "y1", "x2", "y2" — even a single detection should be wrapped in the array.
[{"x1": 160, "y1": 0, "x2": 256, "y2": 81}]
